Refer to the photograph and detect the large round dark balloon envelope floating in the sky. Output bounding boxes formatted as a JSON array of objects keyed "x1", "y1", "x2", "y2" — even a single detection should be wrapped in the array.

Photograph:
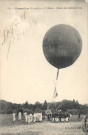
[{"x1": 43, "y1": 24, "x2": 82, "y2": 69}]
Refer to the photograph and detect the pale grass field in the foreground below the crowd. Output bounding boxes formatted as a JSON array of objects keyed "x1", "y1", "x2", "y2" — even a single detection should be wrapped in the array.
[{"x1": 0, "y1": 114, "x2": 87, "y2": 135}]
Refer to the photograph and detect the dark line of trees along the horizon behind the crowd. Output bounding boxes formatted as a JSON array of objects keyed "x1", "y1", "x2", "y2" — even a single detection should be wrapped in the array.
[{"x1": 0, "y1": 99, "x2": 88, "y2": 115}]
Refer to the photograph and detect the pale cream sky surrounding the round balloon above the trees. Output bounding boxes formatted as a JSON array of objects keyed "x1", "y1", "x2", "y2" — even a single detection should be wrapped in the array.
[{"x1": 0, "y1": 1, "x2": 88, "y2": 104}]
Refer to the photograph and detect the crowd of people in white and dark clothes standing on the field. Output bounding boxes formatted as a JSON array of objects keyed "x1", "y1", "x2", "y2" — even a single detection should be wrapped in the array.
[{"x1": 13, "y1": 111, "x2": 71, "y2": 123}]
